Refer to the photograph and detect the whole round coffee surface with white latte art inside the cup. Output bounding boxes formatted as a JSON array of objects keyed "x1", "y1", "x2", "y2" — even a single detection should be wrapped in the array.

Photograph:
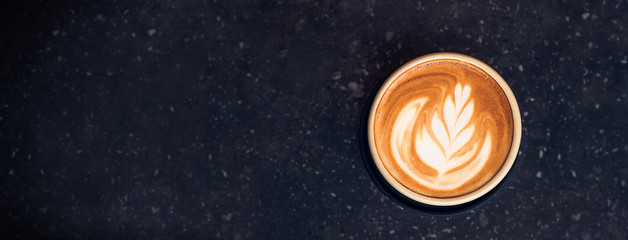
[{"x1": 373, "y1": 59, "x2": 513, "y2": 197}]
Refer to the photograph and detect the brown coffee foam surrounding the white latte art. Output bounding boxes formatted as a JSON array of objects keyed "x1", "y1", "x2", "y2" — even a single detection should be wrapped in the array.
[{"x1": 373, "y1": 59, "x2": 513, "y2": 197}]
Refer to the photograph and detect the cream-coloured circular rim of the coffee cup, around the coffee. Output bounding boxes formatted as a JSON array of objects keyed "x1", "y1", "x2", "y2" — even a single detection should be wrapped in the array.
[{"x1": 367, "y1": 52, "x2": 521, "y2": 207}]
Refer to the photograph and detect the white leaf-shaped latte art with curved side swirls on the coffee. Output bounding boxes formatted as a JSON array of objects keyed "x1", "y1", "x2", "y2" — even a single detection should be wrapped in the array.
[{"x1": 392, "y1": 84, "x2": 491, "y2": 189}]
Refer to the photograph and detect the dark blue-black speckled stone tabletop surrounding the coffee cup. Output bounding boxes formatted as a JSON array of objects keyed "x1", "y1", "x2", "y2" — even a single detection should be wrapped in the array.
[{"x1": 0, "y1": 0, "x2": 628, "y2": 239}]
